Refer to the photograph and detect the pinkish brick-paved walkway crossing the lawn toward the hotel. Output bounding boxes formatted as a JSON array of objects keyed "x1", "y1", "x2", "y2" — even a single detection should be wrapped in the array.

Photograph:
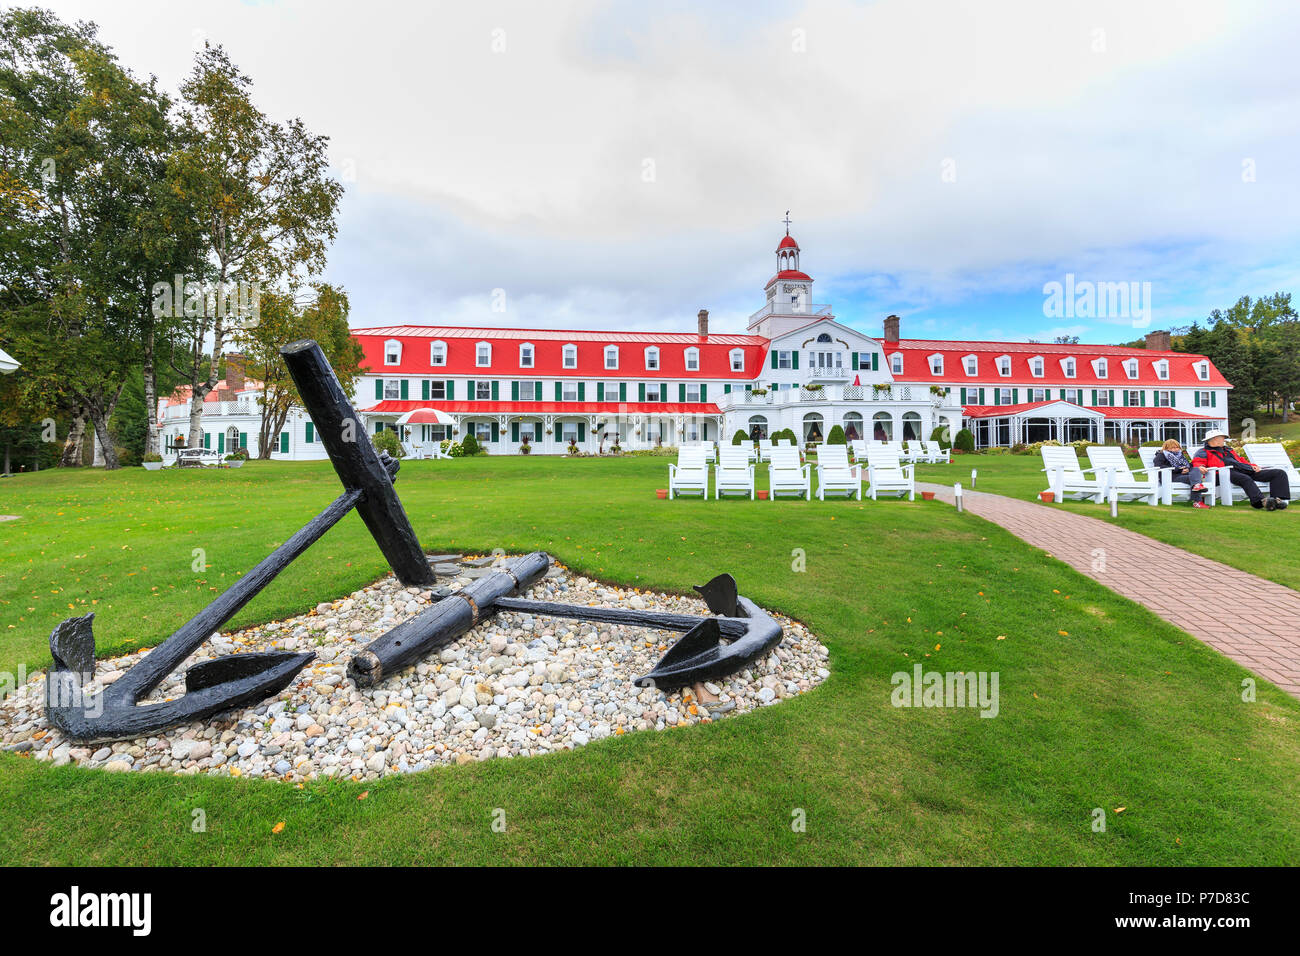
[{"x1": 917, "y1": 481, "x2": 1300, "y2": 697}]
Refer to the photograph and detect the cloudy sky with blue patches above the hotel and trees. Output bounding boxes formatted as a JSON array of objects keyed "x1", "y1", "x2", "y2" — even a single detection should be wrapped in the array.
[{"x1": 32, "y1": 0, "x2": 1300, "y2": 342}]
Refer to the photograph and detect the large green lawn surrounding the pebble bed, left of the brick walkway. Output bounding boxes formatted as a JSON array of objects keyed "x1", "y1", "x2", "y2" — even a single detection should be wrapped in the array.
[{"x1": 0, "y1": 457, "x2": 1300, "y2": 865}]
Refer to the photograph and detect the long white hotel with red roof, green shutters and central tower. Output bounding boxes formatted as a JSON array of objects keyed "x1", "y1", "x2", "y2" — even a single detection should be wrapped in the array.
[{"x1": 159, "y1": 235, "x2": 1231, "y2": 459}]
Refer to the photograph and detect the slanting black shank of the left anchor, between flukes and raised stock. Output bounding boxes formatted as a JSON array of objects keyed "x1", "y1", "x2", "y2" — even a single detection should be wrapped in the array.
[{"x1": 114, "y1": 489, "x2": 361, "y2": 701}]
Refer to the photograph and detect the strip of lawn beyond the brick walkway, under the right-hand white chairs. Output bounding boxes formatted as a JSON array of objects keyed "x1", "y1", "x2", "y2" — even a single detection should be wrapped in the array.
[{"x1": 917, "y1": 454, "x2": 1300, "y2": 591}]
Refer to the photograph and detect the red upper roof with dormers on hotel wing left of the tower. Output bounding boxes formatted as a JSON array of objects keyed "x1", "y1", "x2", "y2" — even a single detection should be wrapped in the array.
[{"x1": 352, "y1": 325, "x2": 768, "y2": 381}]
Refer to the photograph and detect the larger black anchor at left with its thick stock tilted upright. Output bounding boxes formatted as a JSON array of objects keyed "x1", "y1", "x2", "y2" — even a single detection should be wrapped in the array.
[{"x1": 46, "y1": 341, "x2": 434, "y2": 741}]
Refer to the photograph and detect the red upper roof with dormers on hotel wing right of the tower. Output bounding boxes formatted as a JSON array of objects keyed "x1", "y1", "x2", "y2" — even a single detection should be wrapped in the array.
[{"x1": 881, "y1": 338, "x2": 1231, "y2": 389}]
